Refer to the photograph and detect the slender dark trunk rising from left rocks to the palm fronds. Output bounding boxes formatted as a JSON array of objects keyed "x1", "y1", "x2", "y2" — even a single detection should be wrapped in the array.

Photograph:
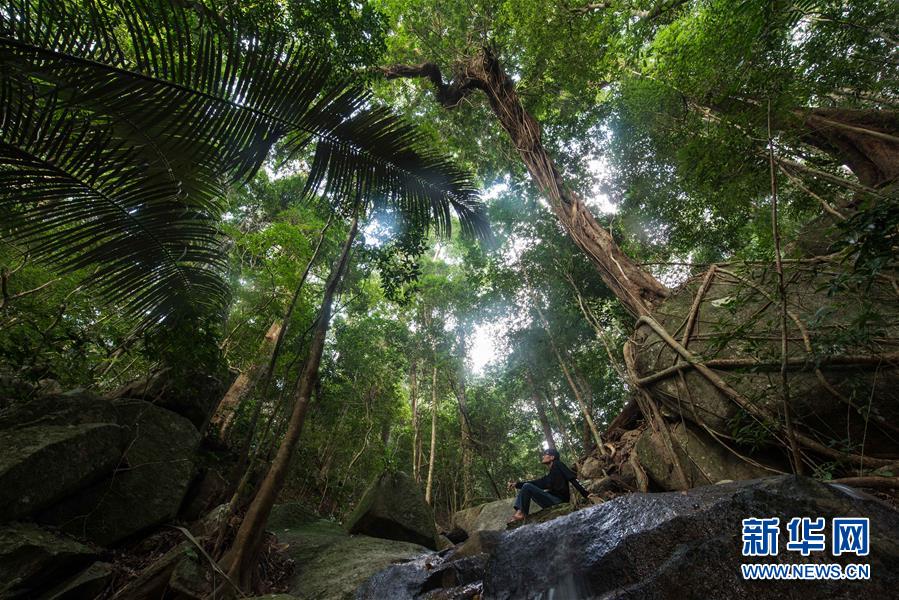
[{"x1": 222, "y1": 209, "x2": 359, "y2": 589}]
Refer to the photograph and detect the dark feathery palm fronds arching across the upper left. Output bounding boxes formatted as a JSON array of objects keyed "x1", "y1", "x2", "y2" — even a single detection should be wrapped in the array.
[{"x1": 0, "y1": 0, "x2": 488, "y2": 324}]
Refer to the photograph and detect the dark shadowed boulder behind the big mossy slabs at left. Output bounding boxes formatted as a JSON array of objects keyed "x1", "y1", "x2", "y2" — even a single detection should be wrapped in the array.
[{"x1": 108, "y1": 369, "x2": 225, "y2": 431}]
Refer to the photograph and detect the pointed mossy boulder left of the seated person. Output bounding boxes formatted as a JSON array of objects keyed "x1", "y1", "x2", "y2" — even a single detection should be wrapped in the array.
[{"x1": 346, "y1": 471, "x2": 437, "y2": 550}]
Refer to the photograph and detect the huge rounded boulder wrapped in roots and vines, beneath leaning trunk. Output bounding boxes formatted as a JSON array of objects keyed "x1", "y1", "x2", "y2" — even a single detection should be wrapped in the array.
[{"x1": 625, "y1": 261, "x2": 899, "y2": 458}]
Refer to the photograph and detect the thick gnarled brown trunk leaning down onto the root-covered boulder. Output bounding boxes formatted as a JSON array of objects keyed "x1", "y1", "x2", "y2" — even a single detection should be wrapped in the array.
[{"x1": 381, "y1": 48, "x2": 669, "y2": 315}]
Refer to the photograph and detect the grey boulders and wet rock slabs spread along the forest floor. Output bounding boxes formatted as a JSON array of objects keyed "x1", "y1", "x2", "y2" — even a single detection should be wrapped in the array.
[{"x1": 0, "y1": 388, "x2": 899, "y2": 600}]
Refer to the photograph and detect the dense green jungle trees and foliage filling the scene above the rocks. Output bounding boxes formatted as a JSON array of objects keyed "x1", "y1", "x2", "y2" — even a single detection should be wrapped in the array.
[{"x1": 0, "y1": 0, "x2": 899, "y2": 589}]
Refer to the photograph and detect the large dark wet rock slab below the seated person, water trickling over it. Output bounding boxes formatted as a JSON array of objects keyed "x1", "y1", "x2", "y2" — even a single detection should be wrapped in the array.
[{"x1": 484, "y1": 476, "x2": 899, "y2": 600}]
